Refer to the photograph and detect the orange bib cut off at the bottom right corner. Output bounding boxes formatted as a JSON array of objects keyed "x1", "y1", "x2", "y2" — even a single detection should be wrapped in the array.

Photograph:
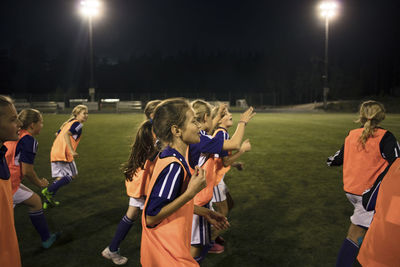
[{"x1": 357, "y1": 158, "x2": 400, "y2": 267}]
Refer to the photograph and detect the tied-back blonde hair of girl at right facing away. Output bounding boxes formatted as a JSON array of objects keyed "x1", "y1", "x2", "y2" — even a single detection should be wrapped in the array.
[{"x1": 356, "y1": 100, "x2": 386, "y2": 147}]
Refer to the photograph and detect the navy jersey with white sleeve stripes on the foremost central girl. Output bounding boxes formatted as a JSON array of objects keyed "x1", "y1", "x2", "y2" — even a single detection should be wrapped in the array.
[{"x1": 145, "y1": 147, "x2": 190, "y2": 216}]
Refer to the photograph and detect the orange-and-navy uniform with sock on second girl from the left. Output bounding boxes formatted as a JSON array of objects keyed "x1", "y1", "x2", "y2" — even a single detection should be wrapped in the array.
[{"x1": 4, "y1": 130, "x2": 55, "y2": 248}]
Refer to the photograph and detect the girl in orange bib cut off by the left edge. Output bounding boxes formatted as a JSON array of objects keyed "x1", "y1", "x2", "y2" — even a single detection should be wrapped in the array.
[{"x1": 0, "y1": 95, "x2": 21, "y2": 267}]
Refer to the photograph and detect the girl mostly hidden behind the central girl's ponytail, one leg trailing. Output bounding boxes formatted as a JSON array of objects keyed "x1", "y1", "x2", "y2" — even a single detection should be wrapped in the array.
[{"x1": 101, "y1": 100, "x2": 161, "y2": 265}]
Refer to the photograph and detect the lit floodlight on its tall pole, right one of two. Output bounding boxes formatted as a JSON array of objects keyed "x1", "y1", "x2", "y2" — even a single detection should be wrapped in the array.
[{"x1": 319, "y1": 1, "x2": 338, "y2": 109}]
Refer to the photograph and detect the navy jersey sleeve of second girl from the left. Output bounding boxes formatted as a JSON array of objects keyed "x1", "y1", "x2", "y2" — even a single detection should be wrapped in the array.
[{"x1": 14, "y1": 135, "x2": 38, "y2": 166}]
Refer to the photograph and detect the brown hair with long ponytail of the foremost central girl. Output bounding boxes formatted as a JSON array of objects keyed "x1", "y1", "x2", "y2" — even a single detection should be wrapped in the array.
[{"x1": 123, "y1": 98, "x2": 190, "y2": 181}]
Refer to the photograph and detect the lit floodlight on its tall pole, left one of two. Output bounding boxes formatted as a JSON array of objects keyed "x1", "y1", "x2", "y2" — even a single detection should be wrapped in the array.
[{"x1": 80, "y1": 0, "x2": 101, "y2": 102}]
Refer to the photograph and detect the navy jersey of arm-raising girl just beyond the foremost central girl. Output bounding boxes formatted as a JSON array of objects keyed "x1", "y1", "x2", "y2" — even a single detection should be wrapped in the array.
[{"x1": 188, "y1": 131, "x2": 224, "y2": 169}]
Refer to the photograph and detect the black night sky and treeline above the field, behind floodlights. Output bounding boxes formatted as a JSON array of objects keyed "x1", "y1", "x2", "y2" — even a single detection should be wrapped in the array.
[{"x1": 0, "y1": 0, "x2": 400, "y2": 105}]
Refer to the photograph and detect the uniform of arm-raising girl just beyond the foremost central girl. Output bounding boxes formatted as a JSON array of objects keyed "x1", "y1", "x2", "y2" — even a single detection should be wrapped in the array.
[{"x1": 187, "y1": 131, "x2": 224, "y2": 254}]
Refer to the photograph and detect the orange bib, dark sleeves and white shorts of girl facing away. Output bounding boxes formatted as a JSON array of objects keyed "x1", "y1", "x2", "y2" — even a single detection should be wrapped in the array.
[{"x1": 327, "y1": 128, "x2": 400, "y2": 228}]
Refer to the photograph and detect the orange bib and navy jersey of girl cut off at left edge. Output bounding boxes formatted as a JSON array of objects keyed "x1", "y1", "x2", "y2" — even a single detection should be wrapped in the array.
[{"x1": 0, "y1": 146, "x2": 21, "y2": 267}]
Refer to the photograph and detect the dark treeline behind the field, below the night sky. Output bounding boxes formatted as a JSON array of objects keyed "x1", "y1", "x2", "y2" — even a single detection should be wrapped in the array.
[{"x1": 0, "y1": 45, "x2": 400, "y2": 105}]
